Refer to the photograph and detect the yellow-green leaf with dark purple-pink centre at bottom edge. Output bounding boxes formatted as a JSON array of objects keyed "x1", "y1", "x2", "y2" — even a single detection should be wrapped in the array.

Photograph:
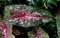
[{"x1": 28, "y1": 27, "x2": 49, "y2": 38}]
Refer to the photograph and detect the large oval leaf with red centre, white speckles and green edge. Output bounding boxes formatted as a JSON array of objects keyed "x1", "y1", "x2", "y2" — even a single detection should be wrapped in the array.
[{"x1": 4, "y1": 5, "x2": 52, "y2": 27}]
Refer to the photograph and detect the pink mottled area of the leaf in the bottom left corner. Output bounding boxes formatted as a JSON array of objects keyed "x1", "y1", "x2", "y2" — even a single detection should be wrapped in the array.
[{"x1": 0, "y1": 21, "x2": 9, "y2": 38}]
